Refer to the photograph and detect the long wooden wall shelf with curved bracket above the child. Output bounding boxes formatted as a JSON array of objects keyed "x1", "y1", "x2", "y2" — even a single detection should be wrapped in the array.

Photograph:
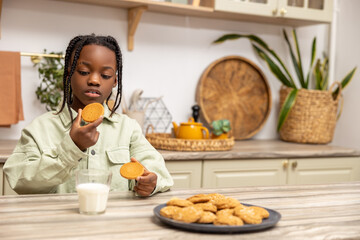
[{"x1": 55, "y1": 0, "x2": 329, "y2": 51}]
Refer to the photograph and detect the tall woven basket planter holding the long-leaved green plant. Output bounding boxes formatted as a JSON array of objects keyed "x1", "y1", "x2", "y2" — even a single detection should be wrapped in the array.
[{"x1": 279, "y1": 82, "x2": 341, "y2": 144}]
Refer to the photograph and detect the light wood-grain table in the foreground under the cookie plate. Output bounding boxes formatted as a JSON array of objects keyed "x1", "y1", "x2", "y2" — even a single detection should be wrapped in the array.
[{"x1": 0, "y1": 182, "x2": 360, "y2": 240}]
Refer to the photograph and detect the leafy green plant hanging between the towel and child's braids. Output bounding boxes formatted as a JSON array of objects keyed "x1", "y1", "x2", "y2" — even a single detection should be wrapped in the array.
[{"x1": 34, "y1": 49, "x2": 64, "y2": 111}]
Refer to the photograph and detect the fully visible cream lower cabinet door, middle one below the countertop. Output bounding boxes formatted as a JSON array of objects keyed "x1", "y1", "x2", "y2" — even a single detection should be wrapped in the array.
[{"x1": 203, "y1": 159, "x2": 287, "y2": 188}]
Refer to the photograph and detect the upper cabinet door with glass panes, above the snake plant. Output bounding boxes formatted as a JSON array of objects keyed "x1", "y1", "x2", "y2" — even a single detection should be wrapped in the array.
[{"x1": 277, "y1": 0, "x2": 333, "y2": 22}]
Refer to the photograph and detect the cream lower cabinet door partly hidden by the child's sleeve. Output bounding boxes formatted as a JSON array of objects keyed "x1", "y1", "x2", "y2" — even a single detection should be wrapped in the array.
[{"x1": 165, "y1": 160, "x2": 202, "y2": 189}]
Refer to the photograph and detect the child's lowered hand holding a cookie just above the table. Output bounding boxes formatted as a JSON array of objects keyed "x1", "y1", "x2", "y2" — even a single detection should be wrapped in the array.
[{"x1": 130, "y1": 158, "x2": 157, "y2": 197}]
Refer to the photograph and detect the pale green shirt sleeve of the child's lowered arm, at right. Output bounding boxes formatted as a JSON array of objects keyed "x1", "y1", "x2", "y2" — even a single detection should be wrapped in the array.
[{"x1": 130, "y1": 120, "x2": 174, "y2": 195}]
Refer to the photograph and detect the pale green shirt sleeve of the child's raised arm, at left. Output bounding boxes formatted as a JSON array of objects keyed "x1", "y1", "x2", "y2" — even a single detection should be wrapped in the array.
[{"x1": 4, "y1": 130, "x2": 87, "y2": 194}]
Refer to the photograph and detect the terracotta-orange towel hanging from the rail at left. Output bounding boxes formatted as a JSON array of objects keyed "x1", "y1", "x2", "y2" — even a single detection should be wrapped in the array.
[{"x1": 0, "y1": 51, "x2": 24, "y2": 127}]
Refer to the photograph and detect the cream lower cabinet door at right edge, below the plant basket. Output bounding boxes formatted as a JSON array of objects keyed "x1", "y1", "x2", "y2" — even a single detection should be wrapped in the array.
[{"x1": 288, "y1": 157, "x2": 360, "y2": 184}]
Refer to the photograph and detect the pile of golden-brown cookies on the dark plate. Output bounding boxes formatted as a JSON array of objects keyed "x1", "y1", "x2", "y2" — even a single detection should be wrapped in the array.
[{"x1": 160, "y1": 193, "x2": 269, "y2": 226}]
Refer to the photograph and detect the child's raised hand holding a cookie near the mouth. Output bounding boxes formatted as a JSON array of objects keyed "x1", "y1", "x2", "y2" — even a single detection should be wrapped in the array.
[{"x1": 70, "y1": 108, "x2": 103, "y2": 151}]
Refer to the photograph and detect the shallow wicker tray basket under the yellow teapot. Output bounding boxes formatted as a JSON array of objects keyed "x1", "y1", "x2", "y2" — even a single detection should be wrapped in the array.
[{"x1": 146, "y1": 133, "x2": 235, "y2": 152}]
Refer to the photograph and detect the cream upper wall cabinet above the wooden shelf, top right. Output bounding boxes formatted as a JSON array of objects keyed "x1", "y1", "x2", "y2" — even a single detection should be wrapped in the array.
[{"x1": 214, "y1": 0, "x2": 333, "y2": 23}]
